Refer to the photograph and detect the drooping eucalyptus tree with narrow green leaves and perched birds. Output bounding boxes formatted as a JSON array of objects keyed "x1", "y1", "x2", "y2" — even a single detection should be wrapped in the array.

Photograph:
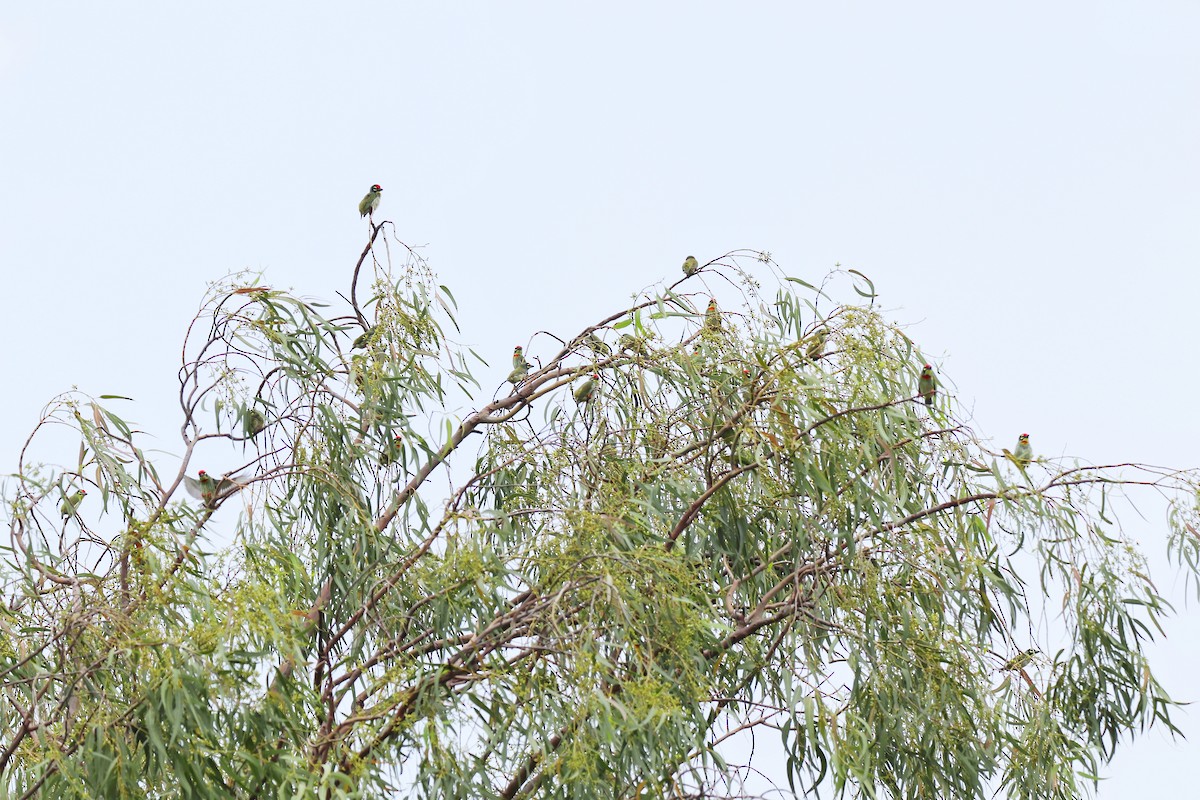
[{"x1": 0, "y1": 223, "x2": 1200, "y2": 800}]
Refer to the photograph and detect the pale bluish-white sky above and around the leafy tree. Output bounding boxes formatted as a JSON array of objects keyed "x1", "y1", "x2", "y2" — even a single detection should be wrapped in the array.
[{"x1": 0, "y1": 1, "x2": 1200, "y2": 800}]
